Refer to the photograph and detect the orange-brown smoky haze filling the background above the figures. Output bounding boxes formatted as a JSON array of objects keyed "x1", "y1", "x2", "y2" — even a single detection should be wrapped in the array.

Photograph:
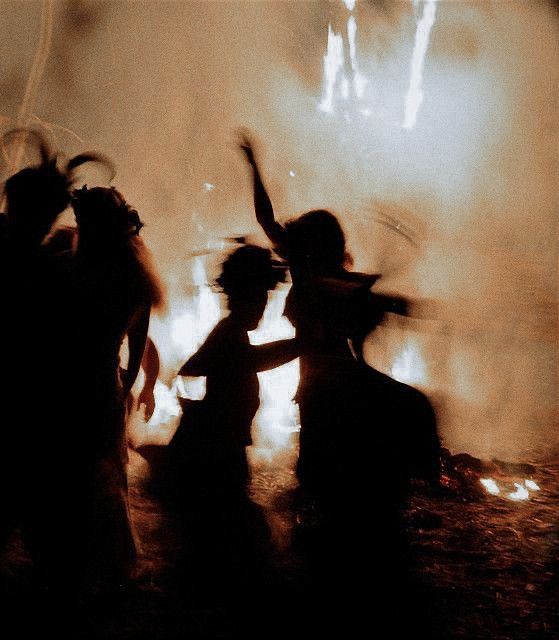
[{"x1": 0, "y1": 0, "x2": 559, "y2": 459}]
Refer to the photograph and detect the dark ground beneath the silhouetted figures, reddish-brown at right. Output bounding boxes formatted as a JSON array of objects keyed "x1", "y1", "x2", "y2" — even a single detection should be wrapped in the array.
[{"x1": 0, "y1": 458, "x2": 559, "y2": 640}]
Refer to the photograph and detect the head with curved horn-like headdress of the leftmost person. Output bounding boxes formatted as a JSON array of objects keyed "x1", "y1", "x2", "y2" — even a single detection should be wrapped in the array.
[{"x1": 1, "y1": 129, "x2": 114, "y2": 249}]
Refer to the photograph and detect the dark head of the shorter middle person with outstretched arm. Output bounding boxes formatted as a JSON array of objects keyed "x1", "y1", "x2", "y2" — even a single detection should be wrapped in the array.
[{"x1": 216, "y1": 245, "x2": 285, "y2": 331}]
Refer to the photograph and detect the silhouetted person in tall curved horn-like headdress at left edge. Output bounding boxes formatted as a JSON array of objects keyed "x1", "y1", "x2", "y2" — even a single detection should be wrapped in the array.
[{"x1": 0, "y1": 131, "x2": 114, "y2": 584}]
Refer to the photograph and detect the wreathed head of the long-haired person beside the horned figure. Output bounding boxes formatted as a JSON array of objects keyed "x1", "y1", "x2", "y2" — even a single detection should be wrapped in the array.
[{"x1": 72, "y1": 186, "x2": 144, "y2": 248}]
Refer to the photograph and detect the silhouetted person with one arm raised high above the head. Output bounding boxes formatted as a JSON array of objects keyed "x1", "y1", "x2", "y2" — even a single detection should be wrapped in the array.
[{"x1": 240, "y1": 136, "x2": 440, "y2": 632}]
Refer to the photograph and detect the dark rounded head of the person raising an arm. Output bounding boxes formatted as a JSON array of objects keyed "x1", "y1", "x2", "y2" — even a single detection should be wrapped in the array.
[{"x1": 286, "y1": 209, "x2": 349, "y2": 273}]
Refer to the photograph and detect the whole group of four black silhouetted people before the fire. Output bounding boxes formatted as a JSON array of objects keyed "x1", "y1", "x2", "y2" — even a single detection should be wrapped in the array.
[{"x1": 0, "y1": 127, "x2": 440, "y2": 632}]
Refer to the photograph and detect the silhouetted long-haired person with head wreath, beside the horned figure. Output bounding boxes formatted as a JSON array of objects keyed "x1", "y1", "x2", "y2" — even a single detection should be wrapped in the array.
[{"x1": 65, "y1": 187, "x2": 163, "y2": 589}]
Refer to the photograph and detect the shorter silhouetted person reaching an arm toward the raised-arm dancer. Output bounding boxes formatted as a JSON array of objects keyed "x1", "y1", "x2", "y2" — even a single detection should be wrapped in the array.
[{"x1": 168, "y1": 245, "x2": 299, "y2": 586}]
